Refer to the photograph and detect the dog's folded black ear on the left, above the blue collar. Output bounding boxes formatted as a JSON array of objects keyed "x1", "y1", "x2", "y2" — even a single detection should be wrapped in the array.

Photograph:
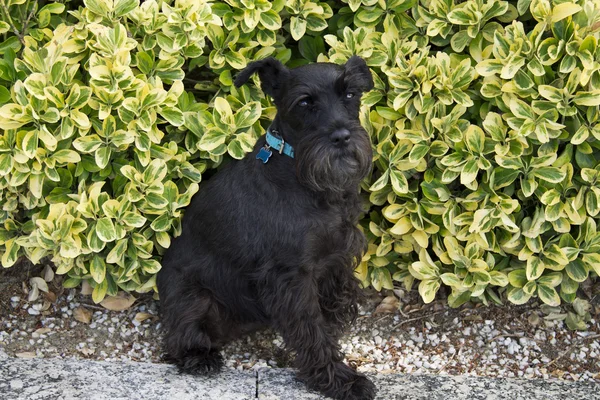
[{"x1": 234, "y1": 57, "x2": 290, "y2": 99}]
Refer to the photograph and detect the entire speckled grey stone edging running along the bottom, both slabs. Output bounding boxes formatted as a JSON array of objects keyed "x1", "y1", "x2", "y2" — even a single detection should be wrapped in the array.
[{"x1": 0, "y1": 350, "x2": 600, "y2": 400}]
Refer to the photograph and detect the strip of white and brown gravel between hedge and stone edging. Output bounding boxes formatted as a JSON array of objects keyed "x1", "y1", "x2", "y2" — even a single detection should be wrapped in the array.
[{"x1": 0, "y1": 270, "x2": 600, "y2": 381}]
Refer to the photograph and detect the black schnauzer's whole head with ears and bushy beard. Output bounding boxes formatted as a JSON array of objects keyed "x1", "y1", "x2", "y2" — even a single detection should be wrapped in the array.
[{"x1": 235, "y1": 56, "x2": 373, "y2": 192}]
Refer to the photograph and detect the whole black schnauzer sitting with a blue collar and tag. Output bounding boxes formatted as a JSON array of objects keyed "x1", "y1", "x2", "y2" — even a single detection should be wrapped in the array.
[{"x1": 158, "y1": 56, "x2": 375, "y2": 399}]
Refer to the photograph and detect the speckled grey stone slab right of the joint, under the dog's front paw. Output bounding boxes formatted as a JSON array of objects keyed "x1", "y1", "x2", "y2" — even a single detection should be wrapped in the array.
[{"x1": 258, "y1": 369, "x2": 600, "y2": 400}]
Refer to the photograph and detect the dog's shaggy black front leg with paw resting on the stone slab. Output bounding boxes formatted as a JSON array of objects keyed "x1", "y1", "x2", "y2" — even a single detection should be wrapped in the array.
[{"x1": 270, "y1": 274, "x2": 375, "y2": 400}]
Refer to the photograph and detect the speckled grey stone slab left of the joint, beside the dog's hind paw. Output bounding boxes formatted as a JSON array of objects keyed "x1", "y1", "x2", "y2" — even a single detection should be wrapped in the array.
[{"x1": 0, "y1": 357, "x2": 256, "y2": 400}]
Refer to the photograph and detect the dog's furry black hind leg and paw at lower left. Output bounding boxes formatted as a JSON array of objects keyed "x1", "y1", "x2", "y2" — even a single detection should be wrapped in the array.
[{"x1": 161, "y1": 286, "x2": 223, "y2": 374}]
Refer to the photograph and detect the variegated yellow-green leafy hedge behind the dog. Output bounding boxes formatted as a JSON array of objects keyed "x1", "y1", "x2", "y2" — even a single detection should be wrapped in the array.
[{"x1": 0, "y1": 0, "x2": 600, "y2": 316}]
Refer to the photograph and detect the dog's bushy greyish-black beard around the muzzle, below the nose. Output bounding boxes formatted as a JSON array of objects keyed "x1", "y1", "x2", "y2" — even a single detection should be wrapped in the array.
[{"x1": 296, "y1": 128, "x2": 372, "y2": 193}]
